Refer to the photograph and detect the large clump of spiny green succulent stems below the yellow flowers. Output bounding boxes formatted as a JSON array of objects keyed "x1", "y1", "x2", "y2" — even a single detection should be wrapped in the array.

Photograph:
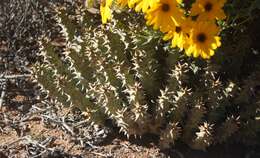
[{"x1": 34, "y1": 1, "x2": 260, "y2": 150}]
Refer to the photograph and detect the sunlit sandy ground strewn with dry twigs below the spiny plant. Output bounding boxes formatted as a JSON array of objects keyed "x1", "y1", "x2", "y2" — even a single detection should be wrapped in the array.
[{"x1": 0, "y1": 101, "x2": 167, "y2": 158}]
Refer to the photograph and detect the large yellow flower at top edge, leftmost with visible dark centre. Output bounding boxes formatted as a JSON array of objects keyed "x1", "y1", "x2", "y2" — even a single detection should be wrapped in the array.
[{"x1": 145, "y1": 0, "x2": 183, "y2": 33}]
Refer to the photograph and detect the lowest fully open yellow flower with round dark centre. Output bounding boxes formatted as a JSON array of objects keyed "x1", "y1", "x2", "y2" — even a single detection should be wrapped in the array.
[{"x1": 184, "y1": 21, "x2": 221, "y2": 59}]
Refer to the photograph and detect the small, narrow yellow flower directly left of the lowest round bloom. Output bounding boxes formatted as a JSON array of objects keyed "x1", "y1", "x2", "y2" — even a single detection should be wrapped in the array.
[{"x1": 163, "y1": 17, "x2": 191, "y2": 50}]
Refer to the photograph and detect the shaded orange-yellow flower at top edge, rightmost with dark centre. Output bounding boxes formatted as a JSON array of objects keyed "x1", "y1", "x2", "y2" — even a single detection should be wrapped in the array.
[{"x1": 191, "y1": 0, "x2": 226, "y2": 21}]
